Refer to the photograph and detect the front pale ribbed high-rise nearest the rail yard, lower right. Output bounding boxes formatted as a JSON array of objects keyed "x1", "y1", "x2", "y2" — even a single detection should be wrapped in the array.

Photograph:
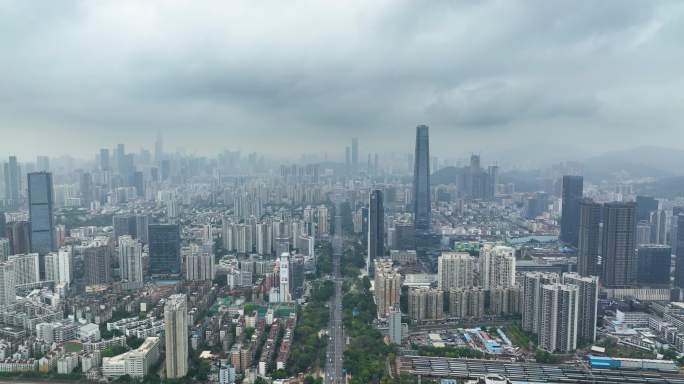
[{"x1": 538, "y1": 284, "x2": 579, "y2": 353}]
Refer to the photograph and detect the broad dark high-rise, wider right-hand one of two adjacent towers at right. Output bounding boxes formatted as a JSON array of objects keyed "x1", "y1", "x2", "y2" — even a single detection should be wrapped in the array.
[{"x1": 601, "y1": 202, "x2": 637, "y2": 288}]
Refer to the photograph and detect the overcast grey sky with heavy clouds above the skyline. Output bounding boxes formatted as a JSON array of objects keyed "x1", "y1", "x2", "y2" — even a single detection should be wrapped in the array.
[{"x1": 0, "y1": 0, "x2": 684, "y2": 164}]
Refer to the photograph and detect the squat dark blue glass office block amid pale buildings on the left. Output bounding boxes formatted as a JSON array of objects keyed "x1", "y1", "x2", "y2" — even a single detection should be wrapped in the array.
[{"x1": 148, "y1": 224, "x2": 181, "y2": 276}]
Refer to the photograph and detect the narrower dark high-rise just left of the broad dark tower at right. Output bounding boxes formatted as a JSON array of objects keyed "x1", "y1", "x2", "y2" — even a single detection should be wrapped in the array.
[{"x1": 577, "y1": 199, "x2": 602, "y2": 276}]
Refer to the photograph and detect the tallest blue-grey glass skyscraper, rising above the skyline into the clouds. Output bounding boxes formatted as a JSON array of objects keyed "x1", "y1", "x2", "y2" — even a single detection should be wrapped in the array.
[{"x1": 413, "y1": 125, "x2": 431, "y2": 235}]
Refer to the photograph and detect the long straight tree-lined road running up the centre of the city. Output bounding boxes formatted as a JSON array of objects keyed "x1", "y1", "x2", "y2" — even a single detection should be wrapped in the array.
[{"x1": 325, "y1": 207, "x2": 345, "y2": 384}]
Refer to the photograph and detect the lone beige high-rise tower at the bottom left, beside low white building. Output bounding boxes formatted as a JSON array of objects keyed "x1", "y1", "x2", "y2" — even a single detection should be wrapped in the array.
[{"x1": 164, "y1": 294, "x2": 188, "y2": 379}]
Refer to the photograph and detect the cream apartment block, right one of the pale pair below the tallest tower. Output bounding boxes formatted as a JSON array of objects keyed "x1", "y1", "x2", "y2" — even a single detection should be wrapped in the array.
[{"x1": 479, "y1": 244, "x2": 515, "y2": 289}]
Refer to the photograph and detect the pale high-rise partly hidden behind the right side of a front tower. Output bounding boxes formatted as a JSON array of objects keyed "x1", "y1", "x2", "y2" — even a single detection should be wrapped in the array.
[{"x1": 562, "y1": 273, "x2": 599, "y2": 343}]
